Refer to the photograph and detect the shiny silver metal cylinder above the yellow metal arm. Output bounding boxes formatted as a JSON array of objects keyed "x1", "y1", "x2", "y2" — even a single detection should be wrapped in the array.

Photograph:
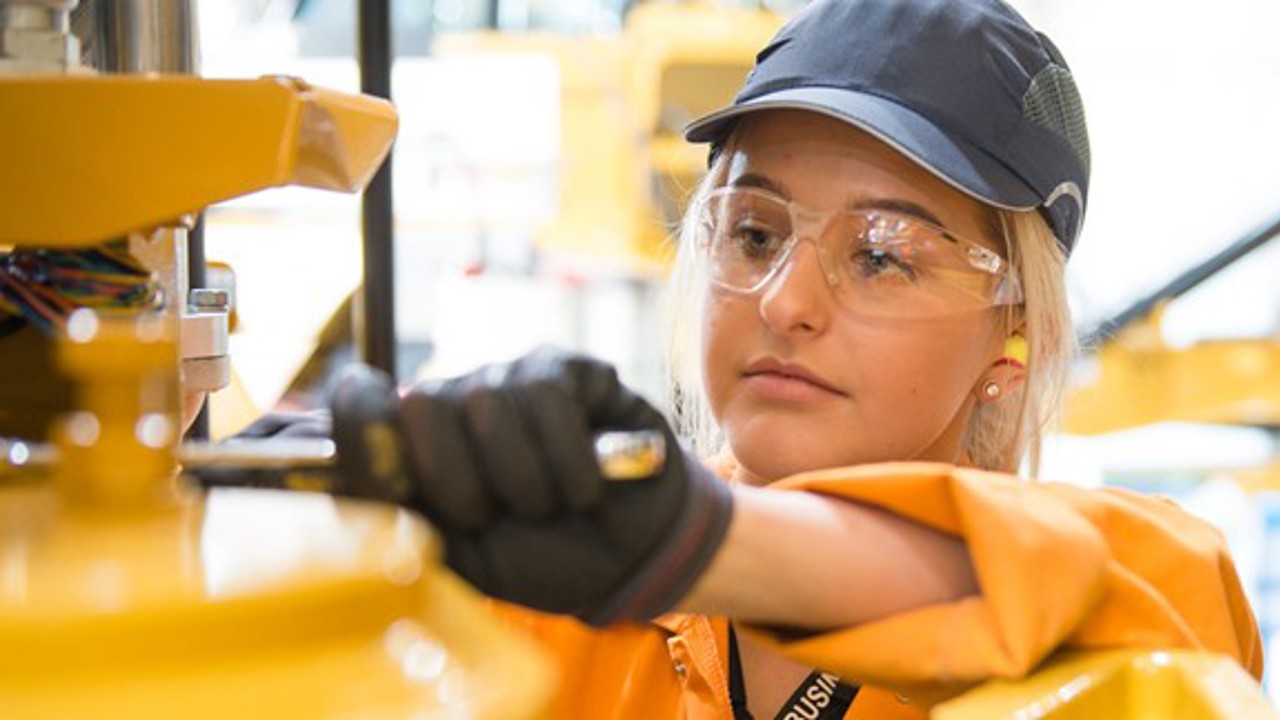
[{"x1": 93, "y1": 0, "x2": 200, "y2": 74}]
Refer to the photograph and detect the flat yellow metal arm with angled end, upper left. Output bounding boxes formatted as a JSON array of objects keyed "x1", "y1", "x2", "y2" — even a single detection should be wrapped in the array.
[{"x1": 0, "y1": 76, "x2": 397, "y2": 247}]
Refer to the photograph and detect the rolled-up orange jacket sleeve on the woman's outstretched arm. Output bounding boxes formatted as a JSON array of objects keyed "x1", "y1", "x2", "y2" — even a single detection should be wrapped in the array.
[{"x1": 755, "y1": 462, "x2": 1262, "y2": 697}]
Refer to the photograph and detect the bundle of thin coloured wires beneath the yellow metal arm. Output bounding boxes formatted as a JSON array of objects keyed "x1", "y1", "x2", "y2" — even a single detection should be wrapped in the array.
[{"x1": 0, "y1": 242, "x2": 159, "y2": 336}]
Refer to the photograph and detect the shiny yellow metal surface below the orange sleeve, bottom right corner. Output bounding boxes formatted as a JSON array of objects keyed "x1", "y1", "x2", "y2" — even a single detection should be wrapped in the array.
[{"x1": 931, "y1": 650, "x2": 1277, "y2": 720}]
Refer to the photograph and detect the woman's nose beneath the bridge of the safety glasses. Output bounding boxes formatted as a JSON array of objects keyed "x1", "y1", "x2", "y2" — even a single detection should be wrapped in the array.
[{"x1": 760, "y1": 240, "x2": 835, "y2": 334}]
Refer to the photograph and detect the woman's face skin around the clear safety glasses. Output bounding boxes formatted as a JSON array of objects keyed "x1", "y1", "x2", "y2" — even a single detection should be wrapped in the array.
[{"x1": 703, "y1": 110, "x2": 1005, "y2": 484}]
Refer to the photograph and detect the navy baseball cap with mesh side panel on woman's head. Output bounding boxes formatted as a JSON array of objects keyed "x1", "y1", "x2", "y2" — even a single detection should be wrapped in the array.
[{"x1": 685, "y1": 0, "x2": 1089, "y2": 254}]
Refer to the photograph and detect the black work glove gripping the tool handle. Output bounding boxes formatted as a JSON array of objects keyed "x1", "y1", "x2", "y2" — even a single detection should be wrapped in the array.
[{"x1": 366, "y1": 350, "x2": 732, "y2": 625}]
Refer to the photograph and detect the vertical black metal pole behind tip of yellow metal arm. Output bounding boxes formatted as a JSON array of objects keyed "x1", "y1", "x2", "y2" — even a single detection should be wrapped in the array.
[{"x1": 355, "y1": 0, "x2": 396, "y2": 378}]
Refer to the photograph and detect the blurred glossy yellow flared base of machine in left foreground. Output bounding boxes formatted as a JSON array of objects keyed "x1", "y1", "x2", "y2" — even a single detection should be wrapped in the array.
[{"x1": 0, "y1": 486, "x2": 550, "y2": 720}]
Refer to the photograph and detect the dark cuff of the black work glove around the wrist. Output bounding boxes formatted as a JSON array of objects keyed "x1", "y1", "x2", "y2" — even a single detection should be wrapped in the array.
[{"x1": 575, "y1": 452, "x2": 733, "y2": 628}]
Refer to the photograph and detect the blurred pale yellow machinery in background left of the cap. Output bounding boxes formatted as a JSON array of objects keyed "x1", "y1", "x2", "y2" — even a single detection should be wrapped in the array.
[{"x1": 435, "y1": 3, "x2": 782, "y2": 277}]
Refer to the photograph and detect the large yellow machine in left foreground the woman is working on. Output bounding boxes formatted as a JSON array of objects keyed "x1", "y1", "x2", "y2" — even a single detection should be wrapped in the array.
[{"x1": 0, "y1": 0, "x2": 550, "y2": 720}]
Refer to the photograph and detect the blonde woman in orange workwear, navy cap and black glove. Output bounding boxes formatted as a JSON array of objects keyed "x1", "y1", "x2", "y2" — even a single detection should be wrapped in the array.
[{"x1": 339, "y1": 0, "x2": 1261, "y2": 719}]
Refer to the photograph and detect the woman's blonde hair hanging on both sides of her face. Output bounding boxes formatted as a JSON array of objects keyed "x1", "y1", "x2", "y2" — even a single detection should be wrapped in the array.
[{"x1": 666, "y1": 151, "x2": 1075, "y2": 475}]
